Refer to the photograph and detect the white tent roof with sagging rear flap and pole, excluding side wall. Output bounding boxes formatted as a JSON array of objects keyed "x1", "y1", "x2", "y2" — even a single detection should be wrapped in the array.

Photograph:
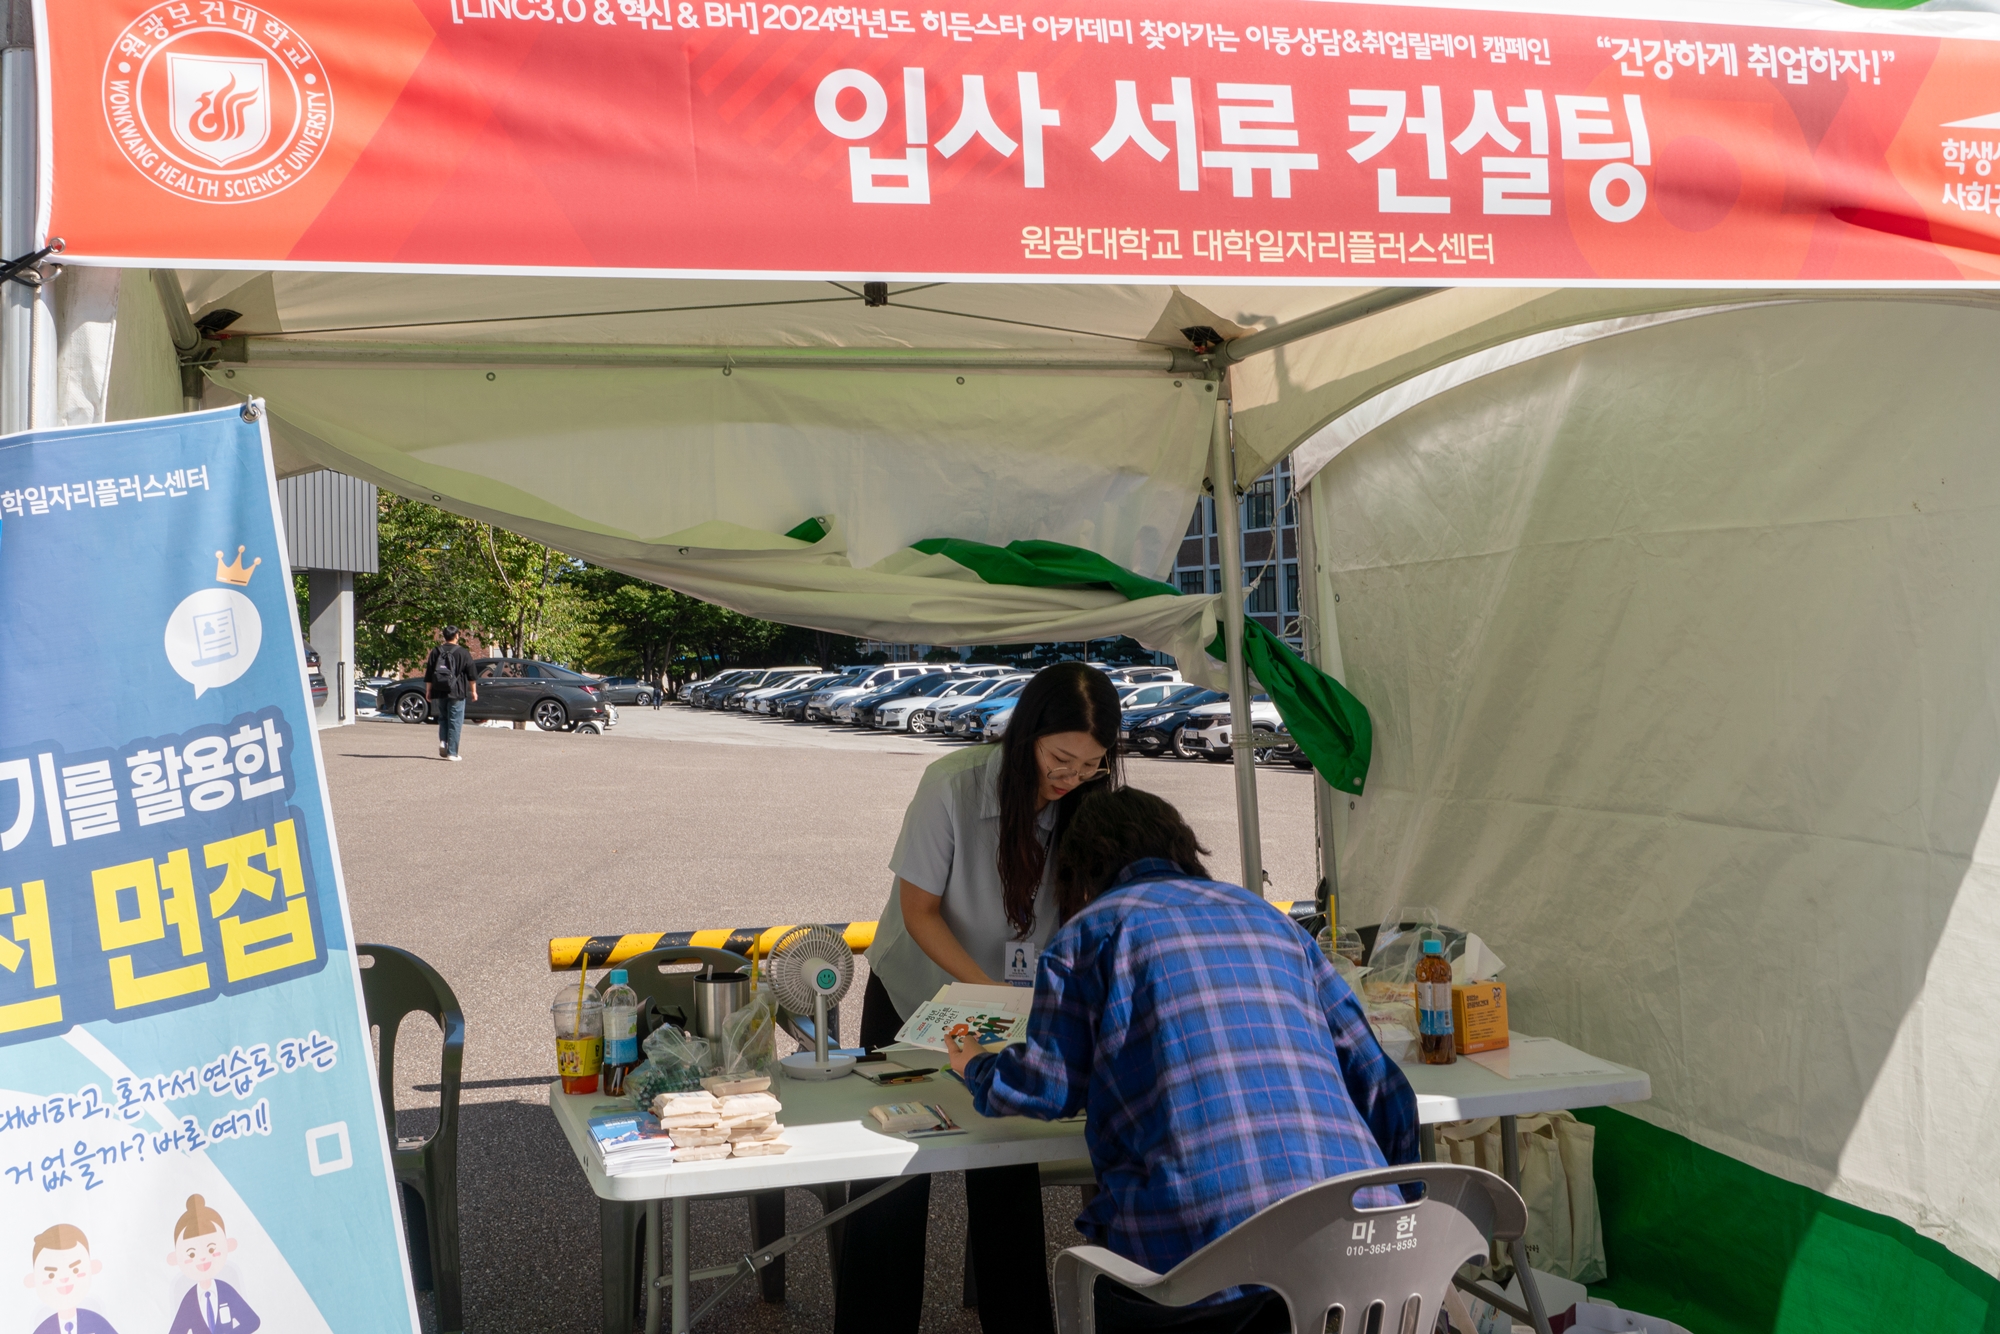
[{"x1": 50, "y1": 270, "x2": 1888, "y2": 884}]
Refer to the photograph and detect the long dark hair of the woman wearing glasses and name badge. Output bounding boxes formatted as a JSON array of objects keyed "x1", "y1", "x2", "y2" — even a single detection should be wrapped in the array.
[{"x1": 1000, "y1": 662, "x2": 1122, "y2": 940}]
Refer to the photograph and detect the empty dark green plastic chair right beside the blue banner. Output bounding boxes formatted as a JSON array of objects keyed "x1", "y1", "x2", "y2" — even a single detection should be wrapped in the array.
[{"x1": 354, "y1": 944, "x2": 466, "y2": 1334}]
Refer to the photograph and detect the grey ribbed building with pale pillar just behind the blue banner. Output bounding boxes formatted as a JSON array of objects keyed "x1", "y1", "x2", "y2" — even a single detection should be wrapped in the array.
[{"x1": 278, "y1": 468, "x2": 378, "y2": 728}]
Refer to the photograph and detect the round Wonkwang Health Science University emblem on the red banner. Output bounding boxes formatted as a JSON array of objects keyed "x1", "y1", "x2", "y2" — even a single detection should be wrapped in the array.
[{"x1": 104, "y1": 0, "x2": 334, "y2": 204}]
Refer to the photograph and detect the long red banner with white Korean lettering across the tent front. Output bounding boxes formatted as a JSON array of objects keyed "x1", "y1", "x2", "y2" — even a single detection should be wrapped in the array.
[{"x1": 27, "y1": 0, "x2": 2000, "y2": 284}]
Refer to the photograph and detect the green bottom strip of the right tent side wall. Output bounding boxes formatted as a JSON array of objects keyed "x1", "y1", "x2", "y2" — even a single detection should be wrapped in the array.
[{"x1": 1576, "y1": 1108, "x2": 2000, "y2": 1334}]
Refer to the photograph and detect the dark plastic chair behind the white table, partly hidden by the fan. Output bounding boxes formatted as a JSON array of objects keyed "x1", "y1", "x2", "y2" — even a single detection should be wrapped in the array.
[{"x1": 596, "y1": 944, "x2": 800, "y2": 1334}]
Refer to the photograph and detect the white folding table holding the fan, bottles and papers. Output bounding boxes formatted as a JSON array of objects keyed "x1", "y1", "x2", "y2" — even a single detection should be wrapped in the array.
[{"x1": 548, "y1": 1050, "x2": 1652, "y2": 1334}]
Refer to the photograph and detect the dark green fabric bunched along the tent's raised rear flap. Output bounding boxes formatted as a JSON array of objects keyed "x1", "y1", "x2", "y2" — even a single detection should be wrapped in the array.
[{"x1": 912, "y1": 538, "x2": 1374, "y2": 792}]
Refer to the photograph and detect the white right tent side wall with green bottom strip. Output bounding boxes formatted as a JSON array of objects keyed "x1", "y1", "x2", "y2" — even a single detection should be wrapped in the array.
[{"x1": 1312, "y1": 298, "x2": 2000, "y2": 1330}]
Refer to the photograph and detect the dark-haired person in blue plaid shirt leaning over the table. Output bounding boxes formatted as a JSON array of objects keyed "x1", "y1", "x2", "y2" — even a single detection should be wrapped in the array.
[{"x1": 950, "y1": 788, "x2": 1418, "y2": 1334}]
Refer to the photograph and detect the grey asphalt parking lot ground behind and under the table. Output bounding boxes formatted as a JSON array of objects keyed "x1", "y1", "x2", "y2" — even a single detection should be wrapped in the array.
[{"x1": 320, "y1": 704, "x2": 1314, "y2": 1334}]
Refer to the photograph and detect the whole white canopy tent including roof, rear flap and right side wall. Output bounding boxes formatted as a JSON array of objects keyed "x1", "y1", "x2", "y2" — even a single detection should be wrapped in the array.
[{"x1": 6, "y1": 4, "x2": 2000, "y2": 1328}]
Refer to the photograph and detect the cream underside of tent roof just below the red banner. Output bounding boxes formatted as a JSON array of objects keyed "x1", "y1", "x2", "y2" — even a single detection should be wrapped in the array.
[{"x1": 182, "y1": 280, "x2": 1988, "y2": 494}]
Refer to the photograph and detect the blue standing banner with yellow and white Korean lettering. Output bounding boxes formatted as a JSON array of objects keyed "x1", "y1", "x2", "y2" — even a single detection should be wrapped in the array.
[{"x1": 0, "y1": 408, "x2": 416, "y2": 1334}]
